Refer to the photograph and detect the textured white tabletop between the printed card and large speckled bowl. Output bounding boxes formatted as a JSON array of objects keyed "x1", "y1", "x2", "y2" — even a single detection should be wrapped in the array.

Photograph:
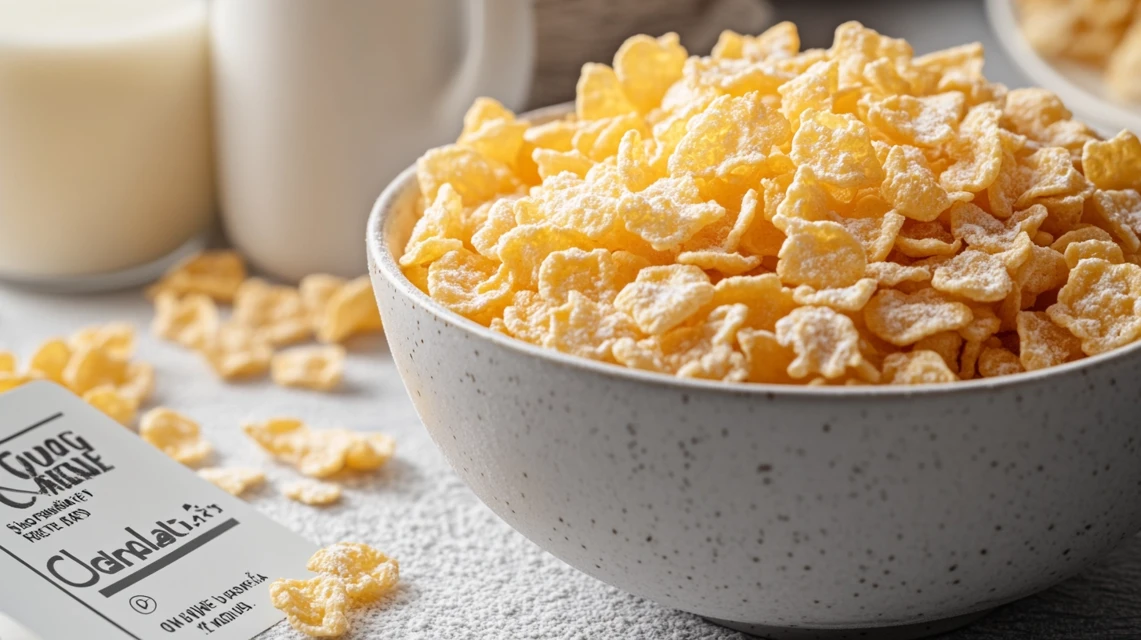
[{"x1": 0, "y1": 287, "x2": 741, "y2": 640}]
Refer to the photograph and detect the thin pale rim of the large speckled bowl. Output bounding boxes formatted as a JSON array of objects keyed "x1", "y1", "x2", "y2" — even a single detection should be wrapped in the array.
[{"x1": 365, "y1": 103, "x2": 1141, "y2": 399}]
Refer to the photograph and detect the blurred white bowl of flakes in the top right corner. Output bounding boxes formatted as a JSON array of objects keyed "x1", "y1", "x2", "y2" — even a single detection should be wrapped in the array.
[{"x1": 987, "y1": 0, "x2": 1141, "y2": 132}]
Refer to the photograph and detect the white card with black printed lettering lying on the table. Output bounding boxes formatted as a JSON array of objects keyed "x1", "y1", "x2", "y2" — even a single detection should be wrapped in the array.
[{"x1": 0, "y1": 382, "x2": 316, "y2": 640}]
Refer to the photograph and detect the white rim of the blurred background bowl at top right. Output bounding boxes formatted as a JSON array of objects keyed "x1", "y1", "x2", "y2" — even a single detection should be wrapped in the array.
[{"x1": 987, "y1": 0, "x2": 1141, "y2": 136}]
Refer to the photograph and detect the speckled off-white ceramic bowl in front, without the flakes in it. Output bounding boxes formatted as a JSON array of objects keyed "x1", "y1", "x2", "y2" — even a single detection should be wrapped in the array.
[{"x1": 367, "y1": 109, "x2": 1141, "y2": 639}]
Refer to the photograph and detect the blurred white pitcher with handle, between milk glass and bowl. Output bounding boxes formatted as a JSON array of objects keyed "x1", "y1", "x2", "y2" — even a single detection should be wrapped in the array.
[{"x1": 211, "y1": 0, "x2": 534, "y2": 281}]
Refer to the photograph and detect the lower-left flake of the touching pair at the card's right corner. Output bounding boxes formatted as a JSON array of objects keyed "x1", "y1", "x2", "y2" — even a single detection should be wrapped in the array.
[{"x1": 269, "y1": 575, "x2": 349, "y2": 638}]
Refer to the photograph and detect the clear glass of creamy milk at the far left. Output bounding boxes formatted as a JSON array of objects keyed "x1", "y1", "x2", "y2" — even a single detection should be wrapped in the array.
[{"x1": 0, "y1": 0, "x2": 215, "y2": 290}]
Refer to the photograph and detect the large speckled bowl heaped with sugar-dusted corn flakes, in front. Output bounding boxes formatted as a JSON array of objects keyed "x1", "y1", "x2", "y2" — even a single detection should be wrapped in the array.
[{"x1": 367, "y1": 23, "x2": 1141, "y2": 638}]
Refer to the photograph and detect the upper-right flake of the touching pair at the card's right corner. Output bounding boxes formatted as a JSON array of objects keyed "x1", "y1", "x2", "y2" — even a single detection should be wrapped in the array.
[{"x1": 306, "y1": 542, "x2": 400, "y2": 603}]
